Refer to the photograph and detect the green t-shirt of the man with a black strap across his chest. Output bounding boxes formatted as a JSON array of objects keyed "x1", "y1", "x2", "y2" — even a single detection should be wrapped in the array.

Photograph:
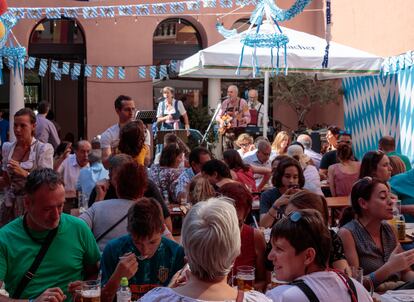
[{"x1": 0, "y1": 214, "x2": 100, "y2": 300}]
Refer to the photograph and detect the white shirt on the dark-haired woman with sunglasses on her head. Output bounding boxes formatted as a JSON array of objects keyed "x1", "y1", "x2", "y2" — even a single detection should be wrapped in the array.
[{"x1": 266, "y1": 271, "x2": 372, "y2": 302}]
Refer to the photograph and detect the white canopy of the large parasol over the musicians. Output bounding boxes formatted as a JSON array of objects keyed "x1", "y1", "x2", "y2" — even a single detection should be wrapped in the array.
[{"x1": 179, "y1": 22, "x2": 383, "y2": 79}]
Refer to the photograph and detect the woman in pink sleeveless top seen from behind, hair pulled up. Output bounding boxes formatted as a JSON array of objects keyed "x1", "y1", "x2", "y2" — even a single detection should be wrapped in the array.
[{"x1": 328, "y1": 144, "x2": 361, "y2": 196}]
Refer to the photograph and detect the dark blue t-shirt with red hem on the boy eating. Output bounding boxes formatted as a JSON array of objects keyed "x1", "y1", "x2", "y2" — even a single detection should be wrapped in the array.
[{"x1": 101, "y1": 235, "x2": 184, "y2": 300}]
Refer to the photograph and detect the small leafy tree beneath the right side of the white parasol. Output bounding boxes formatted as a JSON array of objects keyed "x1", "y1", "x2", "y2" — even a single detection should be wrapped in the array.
[{"x1": 273, "y1": 73, "x2": 343, "y2": 128}]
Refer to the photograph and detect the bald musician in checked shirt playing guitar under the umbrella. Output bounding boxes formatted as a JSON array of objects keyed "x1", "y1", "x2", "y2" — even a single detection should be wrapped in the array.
[{"x1": 216, "y1": 85, "x2": 250, "y2": 151}]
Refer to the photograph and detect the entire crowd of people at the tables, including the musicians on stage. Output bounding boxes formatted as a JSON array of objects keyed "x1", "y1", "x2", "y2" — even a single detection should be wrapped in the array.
[{"x1": 0, "y1": 85, "x2": 414, "y2": 302}]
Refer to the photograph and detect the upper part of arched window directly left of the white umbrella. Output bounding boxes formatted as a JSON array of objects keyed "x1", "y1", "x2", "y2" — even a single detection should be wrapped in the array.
[{"x1": 153, "y1": 18, "x2": 202, "y2": 65}]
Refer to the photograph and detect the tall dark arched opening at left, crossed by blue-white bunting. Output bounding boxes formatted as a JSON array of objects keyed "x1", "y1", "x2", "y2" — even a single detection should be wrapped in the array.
[{"x1": 25, "y1": 18, "x2": 87, "y2": 140}]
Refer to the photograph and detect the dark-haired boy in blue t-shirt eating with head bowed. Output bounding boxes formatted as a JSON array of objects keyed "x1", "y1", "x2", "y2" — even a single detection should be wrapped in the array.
[{"x1": 101, "y1": 198, "x2": 184, "y2": 302}]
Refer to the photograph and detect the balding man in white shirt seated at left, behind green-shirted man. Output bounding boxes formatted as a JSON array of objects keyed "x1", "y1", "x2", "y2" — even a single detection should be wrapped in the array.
[{"x1": 55, "y1": 140, "x2": 92, "y2": 213}]
